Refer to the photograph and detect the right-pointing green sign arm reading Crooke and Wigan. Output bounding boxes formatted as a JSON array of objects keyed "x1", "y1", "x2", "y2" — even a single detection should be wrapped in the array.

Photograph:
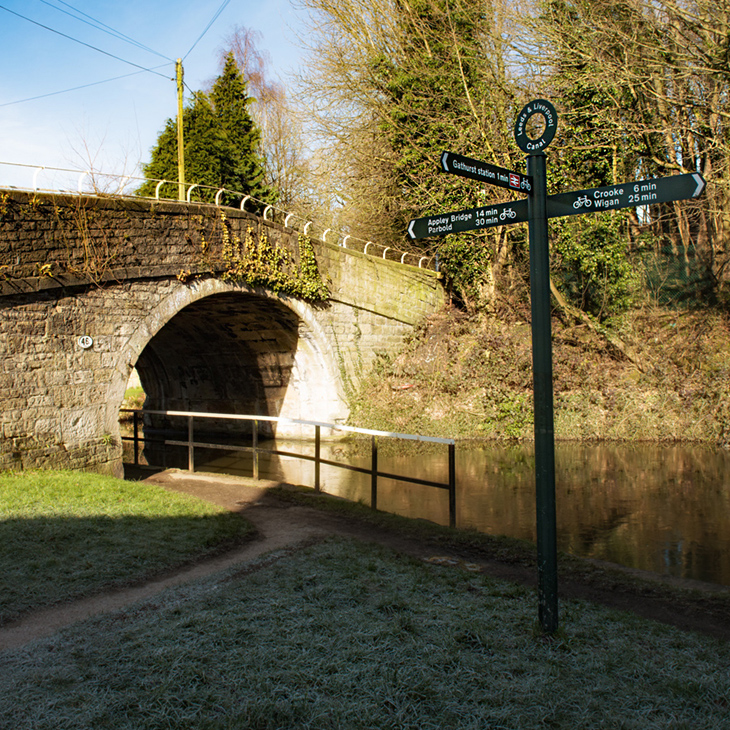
[{"x1": 547, "y1": 172, "x2": 705, "y2": 218}]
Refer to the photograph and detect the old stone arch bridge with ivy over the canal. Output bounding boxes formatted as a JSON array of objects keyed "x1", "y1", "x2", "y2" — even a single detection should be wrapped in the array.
[{"x1": 0, "y1": 191, "x2": 444, "y2": 474}]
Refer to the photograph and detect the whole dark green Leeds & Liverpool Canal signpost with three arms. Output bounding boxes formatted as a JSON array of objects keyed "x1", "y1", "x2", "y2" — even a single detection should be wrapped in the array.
[{"x1": 408, "y1": 99, "x2": 705, "y2": 633}]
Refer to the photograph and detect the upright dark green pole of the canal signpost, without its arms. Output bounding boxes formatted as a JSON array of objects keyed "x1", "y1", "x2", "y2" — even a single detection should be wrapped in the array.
[{"x1": 527, "y1": 151, "x2": 558, "y2": 633}]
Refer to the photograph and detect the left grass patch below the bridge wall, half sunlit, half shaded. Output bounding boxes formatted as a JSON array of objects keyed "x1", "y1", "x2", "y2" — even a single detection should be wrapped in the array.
[{"x1": 0, "y1": 471, "x2": 251, "y2": 624}]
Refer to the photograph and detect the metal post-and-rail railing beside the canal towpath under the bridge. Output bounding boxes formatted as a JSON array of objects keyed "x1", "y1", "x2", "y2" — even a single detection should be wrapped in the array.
[{"x1": 120, "y1": 408, "x2": 456, "y2": 527}]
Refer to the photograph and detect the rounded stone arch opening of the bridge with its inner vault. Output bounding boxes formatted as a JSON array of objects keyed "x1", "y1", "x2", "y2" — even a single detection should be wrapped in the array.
[{"x1": 106, "y1": 278, "x2": 348, "y2": 450}]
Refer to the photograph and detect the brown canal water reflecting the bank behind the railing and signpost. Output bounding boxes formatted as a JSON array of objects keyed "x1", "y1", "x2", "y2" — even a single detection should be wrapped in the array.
[{"x1": 198, "y1": 441, "x2": 730, "y2": 585}]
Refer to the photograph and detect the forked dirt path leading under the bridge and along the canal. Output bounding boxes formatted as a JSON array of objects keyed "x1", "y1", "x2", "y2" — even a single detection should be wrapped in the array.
[{"x1": 0, "y1": 470, "x2": 730, "y2": 650}]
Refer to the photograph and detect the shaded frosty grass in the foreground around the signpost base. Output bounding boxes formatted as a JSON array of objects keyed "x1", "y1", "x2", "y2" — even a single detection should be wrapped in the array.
[{"x1": 0, "y1": 539, "x2": 730, "y2": 730}]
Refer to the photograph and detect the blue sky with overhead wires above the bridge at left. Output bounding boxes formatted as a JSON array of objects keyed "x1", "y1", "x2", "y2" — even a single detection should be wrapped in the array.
[{"x1": 0, "y1": 0, "x2": 300, "y2": 187}]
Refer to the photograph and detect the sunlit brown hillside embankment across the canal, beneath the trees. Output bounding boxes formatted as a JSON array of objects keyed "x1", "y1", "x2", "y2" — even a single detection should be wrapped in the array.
[{"x1": 351, "y1": 308, "x2": 730, "y2": 448}]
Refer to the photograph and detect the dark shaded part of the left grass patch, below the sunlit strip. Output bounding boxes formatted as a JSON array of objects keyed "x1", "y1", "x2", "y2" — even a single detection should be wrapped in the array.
[{"x1": 0, "y1": 512, "x2": 253, "y2": 625}]
